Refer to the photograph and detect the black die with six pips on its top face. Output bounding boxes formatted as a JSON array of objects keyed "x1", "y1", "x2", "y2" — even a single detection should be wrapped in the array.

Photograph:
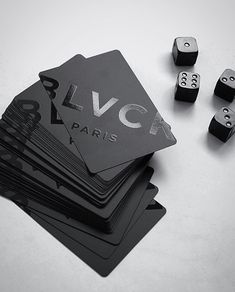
[{"x1": 175, "y1": 72, "x2": 200, "y2": 102}]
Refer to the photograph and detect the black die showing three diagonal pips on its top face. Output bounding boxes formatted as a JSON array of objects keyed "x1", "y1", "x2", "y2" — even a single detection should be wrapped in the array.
[{"x1": 209, "y1": 107, "x2": 235, "y2": 142}]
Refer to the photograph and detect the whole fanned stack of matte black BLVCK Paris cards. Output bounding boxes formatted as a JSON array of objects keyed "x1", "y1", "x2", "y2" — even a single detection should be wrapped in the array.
[{"x1": 0, "y1": 51, "x2": 176, "y2": 276}]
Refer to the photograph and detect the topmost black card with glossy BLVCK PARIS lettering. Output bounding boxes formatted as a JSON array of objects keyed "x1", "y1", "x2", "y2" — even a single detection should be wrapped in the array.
[{"x1": 40, "y1": 50, "x2": 176, "y2": 173}]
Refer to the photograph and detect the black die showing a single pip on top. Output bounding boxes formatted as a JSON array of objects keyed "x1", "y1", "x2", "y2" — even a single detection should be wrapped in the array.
[{"x1": 172, "y1": 37, "x2": 198, "y2": 66}]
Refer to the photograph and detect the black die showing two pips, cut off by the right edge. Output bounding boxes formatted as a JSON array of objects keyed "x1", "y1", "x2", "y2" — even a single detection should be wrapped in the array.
[{"x1": 214, "y1": 69, "x2": 235, "y2": 102}]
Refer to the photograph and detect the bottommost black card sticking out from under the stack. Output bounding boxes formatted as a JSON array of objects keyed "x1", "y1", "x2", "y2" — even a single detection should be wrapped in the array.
[{"x1": 30, "y1": 201, "x2": 166, "y2": 277}]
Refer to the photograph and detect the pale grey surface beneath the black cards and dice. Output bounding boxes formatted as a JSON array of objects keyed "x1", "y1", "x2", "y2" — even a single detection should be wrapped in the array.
[{"x1": 0, "y1": 0, "x2": 235, "y2": 292}]
